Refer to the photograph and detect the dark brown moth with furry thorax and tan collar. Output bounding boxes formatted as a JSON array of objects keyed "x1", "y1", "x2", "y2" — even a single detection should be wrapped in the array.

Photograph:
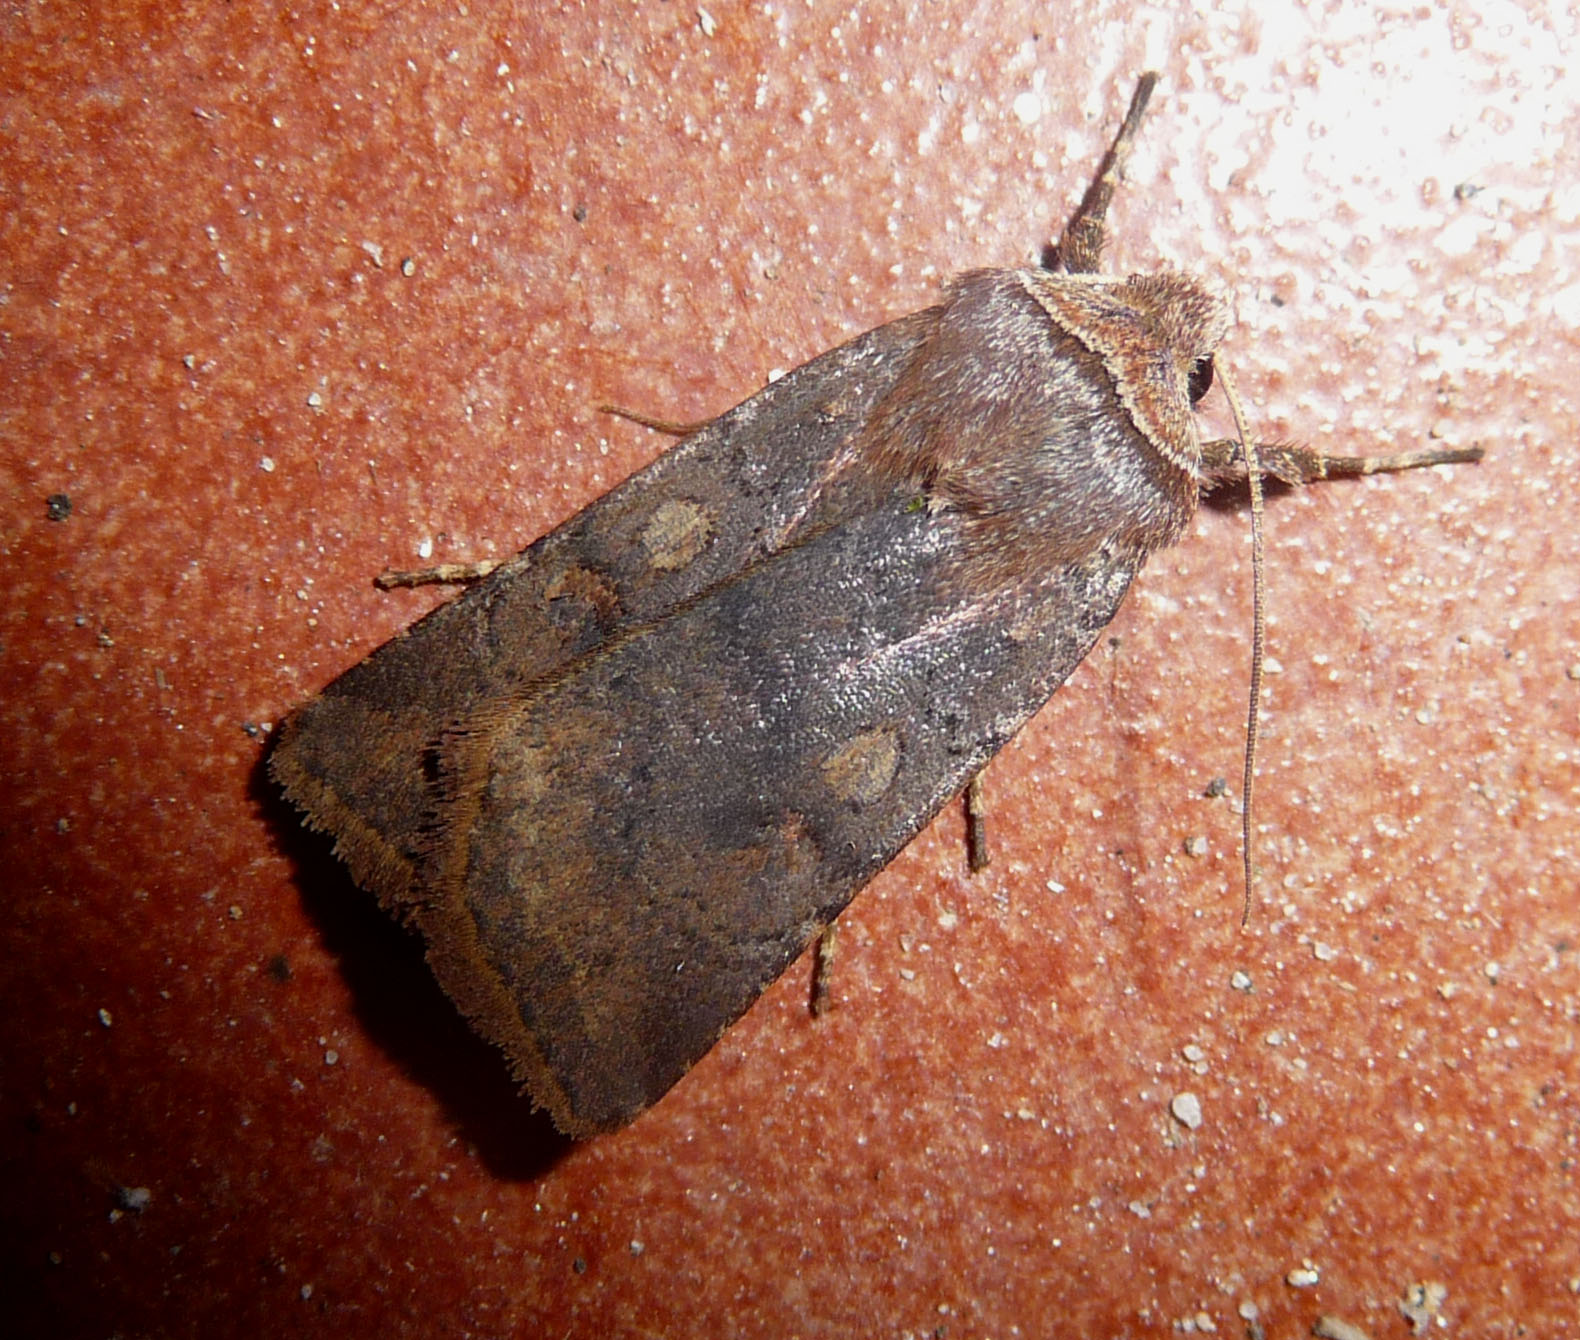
[{"x1": 270, "y1": 74, "x2": 1477, "y2": 1136}]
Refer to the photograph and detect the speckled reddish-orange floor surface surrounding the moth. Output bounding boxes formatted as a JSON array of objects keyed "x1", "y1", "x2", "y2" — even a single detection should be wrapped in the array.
[{"x1": 0, "y1": 0, "x2": 1580, "y2": 1337}]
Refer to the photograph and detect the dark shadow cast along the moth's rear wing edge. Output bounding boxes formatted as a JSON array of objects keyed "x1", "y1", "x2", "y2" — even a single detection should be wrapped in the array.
[{"x1": 250, "y1": 751, "x2": 572, "y2": 1182}]
